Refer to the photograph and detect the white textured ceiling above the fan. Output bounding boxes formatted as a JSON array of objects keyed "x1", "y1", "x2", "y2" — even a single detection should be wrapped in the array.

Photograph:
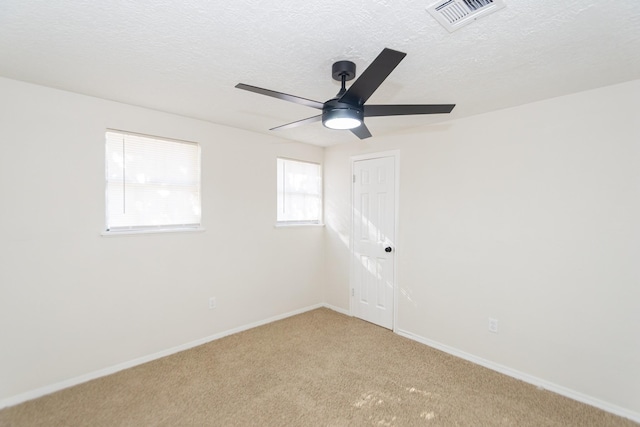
[{"x1": 0, "y1": 0, "x2": 640, "y2": 146}]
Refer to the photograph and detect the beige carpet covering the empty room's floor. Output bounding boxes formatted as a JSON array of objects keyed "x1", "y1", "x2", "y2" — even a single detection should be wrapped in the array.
[{"x1": 0, "y1": 309, "x2": 638, "y2": 427}]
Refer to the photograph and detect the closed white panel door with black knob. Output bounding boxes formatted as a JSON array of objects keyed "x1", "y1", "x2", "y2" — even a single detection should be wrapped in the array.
[{"x1": 351, "y1": 157, "x2": 396, "y2": 329}]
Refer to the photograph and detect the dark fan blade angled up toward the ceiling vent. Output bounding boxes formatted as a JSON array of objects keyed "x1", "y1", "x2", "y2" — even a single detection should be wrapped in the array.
[{"x1": 340, "y1": 48, "x2": 407, "y2": 105}]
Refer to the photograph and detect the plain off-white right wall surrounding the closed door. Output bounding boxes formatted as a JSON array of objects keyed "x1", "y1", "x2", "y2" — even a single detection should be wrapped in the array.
[{"x1": 325, "y1": 80, "x2": 640, "y2": 420}]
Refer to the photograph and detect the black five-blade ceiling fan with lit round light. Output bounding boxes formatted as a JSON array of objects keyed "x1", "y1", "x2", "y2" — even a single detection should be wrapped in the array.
[{"x1": 236, "y1": 48, "x2": 455, "y2": 139}]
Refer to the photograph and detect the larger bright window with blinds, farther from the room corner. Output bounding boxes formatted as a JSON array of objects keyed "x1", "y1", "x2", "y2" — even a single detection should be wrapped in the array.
[{"x1": 106, "y1": 131, "x2": 201, "y2": 232}]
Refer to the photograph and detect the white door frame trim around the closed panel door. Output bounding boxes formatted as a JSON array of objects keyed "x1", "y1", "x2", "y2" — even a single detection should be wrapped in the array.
[{"x1": 349, "y1": 150, "x2": 400, "y2": 332}]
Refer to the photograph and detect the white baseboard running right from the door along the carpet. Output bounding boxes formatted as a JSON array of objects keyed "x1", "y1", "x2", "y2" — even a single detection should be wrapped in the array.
[{"x1": 395, "y1": 329, "x2": 640, "y2": 422}]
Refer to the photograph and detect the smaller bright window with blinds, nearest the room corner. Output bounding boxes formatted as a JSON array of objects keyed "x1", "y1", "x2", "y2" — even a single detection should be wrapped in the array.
[{"x1": 278, "y1": 158, "x2": 322, "y2": 224}]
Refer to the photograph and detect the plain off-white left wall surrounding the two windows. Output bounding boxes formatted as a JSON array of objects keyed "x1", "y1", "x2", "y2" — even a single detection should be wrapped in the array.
[{"x1": 0, "y1": 79, "x2": 324, "y2": 402}]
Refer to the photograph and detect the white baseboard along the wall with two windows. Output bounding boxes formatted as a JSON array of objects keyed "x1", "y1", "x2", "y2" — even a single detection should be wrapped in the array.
[{"x1": 0, "y1": 304, "x2": 324, "y2": 409}]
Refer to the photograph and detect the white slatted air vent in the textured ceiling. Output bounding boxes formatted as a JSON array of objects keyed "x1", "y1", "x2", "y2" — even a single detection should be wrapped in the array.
[{"x1": 427, "y1": 0, "x2": 505, "y2": 32}]
